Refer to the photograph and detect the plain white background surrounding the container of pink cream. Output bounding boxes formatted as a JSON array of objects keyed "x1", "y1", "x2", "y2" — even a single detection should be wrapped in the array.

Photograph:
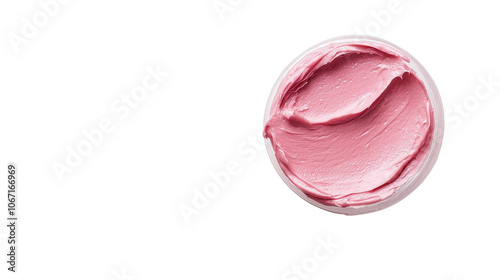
[{"x1": 0, "y1": 0, "x2": 500, "y2": 280}]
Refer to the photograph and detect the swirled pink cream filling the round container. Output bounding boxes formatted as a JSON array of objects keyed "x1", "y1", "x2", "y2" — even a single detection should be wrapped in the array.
[{"x1": 264, "y1": 41, "x2": 434, "y2": 207}]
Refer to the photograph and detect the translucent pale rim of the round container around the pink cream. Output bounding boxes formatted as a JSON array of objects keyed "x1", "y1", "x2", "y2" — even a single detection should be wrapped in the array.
[{"x1": 264, "y1": 35, "x2": 444, "y2": 215}]
